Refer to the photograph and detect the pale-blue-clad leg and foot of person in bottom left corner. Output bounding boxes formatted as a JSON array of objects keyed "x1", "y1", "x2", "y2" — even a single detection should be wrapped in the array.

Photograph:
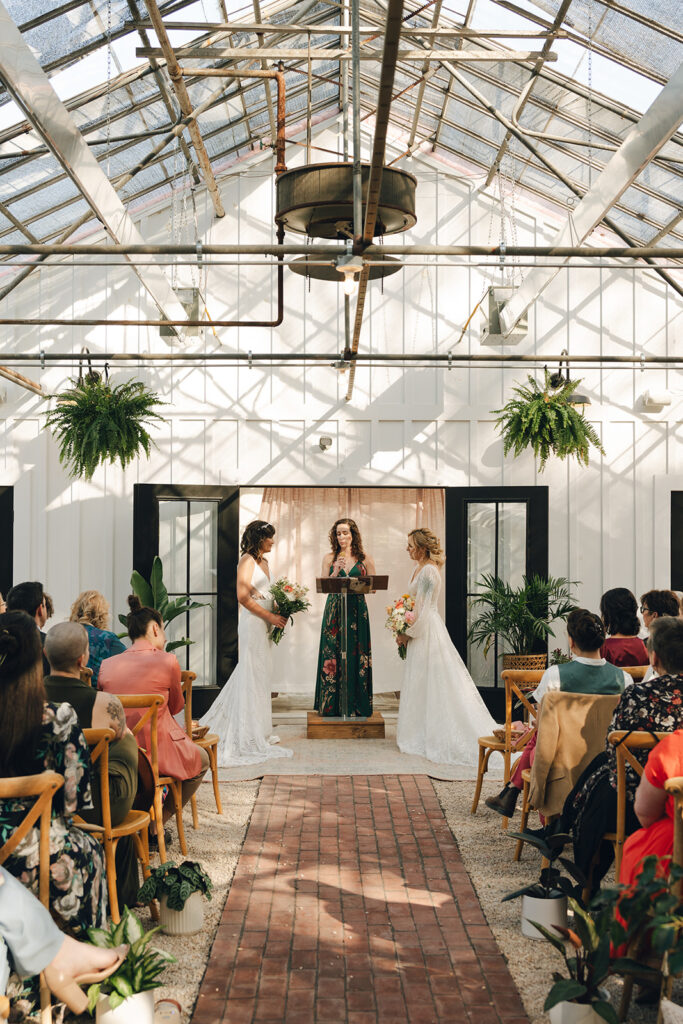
[{"x1": 0, "y1": 867, "x2": 128, "y2": 1016}]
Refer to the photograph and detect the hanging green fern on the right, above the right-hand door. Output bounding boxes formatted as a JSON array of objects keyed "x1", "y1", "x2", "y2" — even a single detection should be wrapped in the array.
[{"x1": 493, "y1": 370, "x2": 605, "y2": 472}]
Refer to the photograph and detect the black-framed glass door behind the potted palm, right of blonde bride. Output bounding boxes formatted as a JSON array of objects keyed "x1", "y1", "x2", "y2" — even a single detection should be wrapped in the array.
[{"x1": 445, "y1": 486, "x2": 548, "y2": 711}]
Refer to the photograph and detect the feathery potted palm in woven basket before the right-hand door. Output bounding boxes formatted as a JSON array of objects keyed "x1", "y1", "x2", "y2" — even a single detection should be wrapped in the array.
[{"x1": 469, "y1": 572, "x2": 577, "y2": 669}]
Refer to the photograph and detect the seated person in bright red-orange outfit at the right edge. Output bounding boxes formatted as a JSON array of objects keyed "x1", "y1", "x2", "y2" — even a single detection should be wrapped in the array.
[{"x1": 618, "y1": 729, "x2": 683, "y2": 886}]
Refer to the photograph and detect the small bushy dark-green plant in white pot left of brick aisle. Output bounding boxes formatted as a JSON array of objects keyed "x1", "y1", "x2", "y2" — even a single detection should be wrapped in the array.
[{"x1": 137, "y1": 860, "x2": 213, "y2": 935}]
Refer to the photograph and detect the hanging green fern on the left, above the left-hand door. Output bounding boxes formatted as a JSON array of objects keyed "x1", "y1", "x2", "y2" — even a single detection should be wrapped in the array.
[{"x1": 46, "y1": 374, "x2": 166, "y2": 480}]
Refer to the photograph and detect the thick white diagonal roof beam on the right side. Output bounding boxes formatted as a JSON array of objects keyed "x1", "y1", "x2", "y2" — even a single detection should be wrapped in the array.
[{"x1": 501, "y1": 63, "x2": 683, "y2": 335}]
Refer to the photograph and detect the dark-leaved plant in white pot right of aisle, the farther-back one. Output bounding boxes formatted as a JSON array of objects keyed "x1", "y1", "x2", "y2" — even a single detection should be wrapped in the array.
[{"x1": 503, "y1": 831, "x2": 586, "y2": 939}]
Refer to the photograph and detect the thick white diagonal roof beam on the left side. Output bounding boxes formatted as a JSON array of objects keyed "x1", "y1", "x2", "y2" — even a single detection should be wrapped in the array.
[{"x1": 0, "y1": 0, "x2": 186, "y2": 337}]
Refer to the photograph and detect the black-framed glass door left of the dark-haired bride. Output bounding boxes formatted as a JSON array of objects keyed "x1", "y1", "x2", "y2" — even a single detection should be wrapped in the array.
[{"x1": 133, "y1": 483, "x2": 240, "y2": 714}]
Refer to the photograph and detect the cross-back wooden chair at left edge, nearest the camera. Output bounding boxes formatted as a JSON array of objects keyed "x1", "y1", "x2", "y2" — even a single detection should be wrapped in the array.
[{"x1": 0, "y1": 771, "x2": 65, "y2": 1024}]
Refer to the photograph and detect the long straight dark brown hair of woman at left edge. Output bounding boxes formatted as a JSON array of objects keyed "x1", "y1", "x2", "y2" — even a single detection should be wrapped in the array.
[{"x1": 0, "y1": 611, "x2": 46, "y2": 776}]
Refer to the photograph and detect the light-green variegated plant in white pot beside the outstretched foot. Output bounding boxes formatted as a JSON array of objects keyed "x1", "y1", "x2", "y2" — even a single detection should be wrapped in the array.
[{"x1": 88, "y1": 907, "x2": 175, "y2": 1024}]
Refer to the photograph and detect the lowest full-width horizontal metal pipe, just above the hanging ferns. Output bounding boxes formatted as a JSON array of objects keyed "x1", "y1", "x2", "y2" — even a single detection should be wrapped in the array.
[{"x1": 2, "y1": 354, "x2": 683, "y2": 367}]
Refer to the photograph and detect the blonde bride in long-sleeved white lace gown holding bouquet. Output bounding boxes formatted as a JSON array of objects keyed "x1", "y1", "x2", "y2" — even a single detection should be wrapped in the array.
[{"x1": 396, "y1": 527, "x2": 496, "y2": 768}]
